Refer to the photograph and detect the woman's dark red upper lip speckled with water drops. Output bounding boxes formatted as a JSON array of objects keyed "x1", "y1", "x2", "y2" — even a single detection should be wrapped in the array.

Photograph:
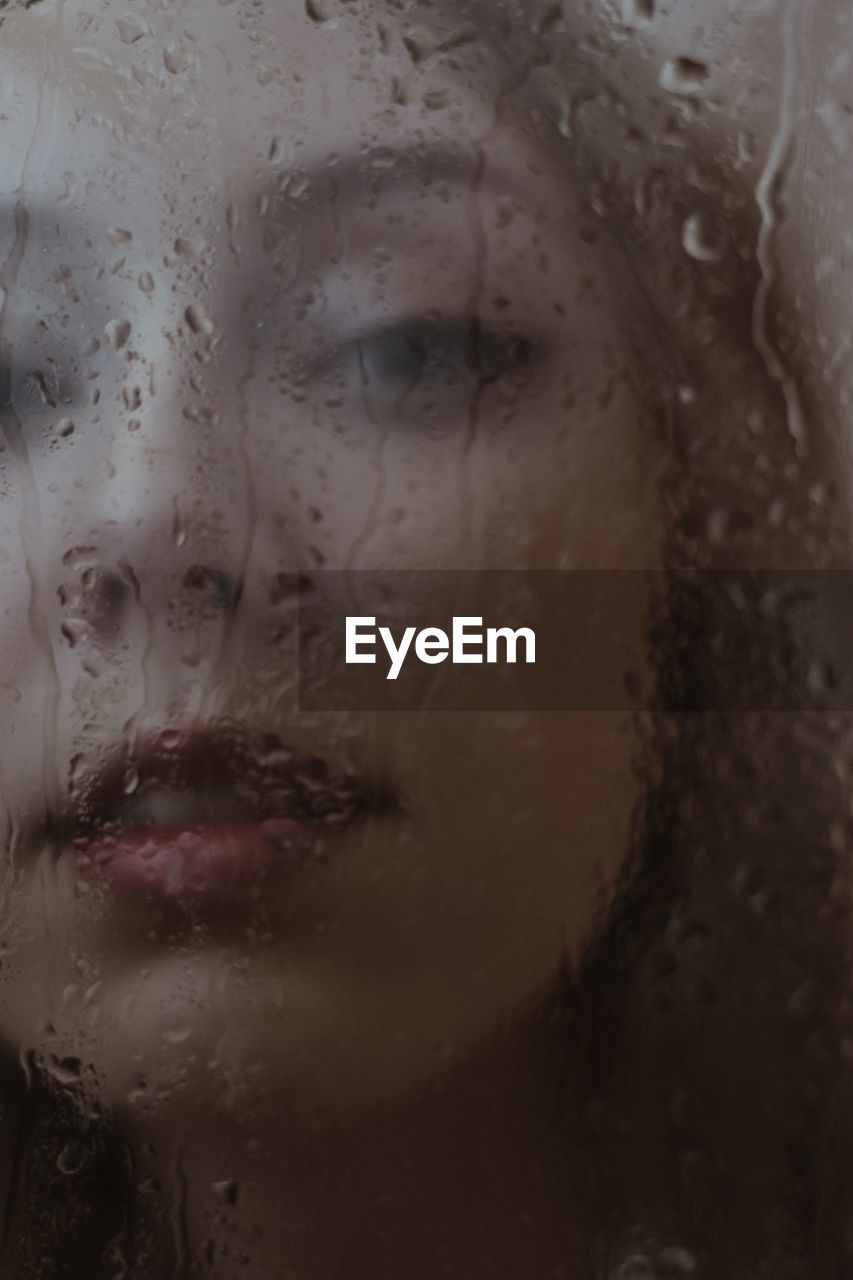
[{"x1": 59, "y1": 726, "x2": 397, "y2": 842}]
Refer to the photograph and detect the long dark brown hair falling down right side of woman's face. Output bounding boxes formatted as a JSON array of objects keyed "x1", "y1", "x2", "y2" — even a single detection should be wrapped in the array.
[{"x1": 517, "y1": 7, "x2": 850, "y2": 1280}]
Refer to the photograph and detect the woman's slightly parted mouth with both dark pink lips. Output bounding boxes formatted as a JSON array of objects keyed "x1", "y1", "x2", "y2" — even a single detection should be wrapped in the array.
[{"x1": 59, "y1": 728, "x2": 397, "y2": 904}]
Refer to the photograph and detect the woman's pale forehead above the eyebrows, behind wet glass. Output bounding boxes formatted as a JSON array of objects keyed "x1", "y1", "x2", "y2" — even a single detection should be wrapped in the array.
[{"x1": 3, "y1": 0, "x2": 517, "y2": 180}]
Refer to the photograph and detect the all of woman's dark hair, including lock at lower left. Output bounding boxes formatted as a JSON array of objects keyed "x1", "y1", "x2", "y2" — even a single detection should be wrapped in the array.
[{"x1": 0, "y1": 3, "x2": 853, "y2": 1280}]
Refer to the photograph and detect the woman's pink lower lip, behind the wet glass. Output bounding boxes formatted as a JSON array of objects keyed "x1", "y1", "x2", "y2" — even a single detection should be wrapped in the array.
[{"x1": 78, "y1": 818, "x2": 351, "y2": 904}]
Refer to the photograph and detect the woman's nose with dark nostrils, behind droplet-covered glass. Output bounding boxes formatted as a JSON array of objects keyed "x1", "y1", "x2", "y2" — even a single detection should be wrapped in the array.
[{"x1": 63, "y1": 342, "x2": 289, "y2": 660}]
